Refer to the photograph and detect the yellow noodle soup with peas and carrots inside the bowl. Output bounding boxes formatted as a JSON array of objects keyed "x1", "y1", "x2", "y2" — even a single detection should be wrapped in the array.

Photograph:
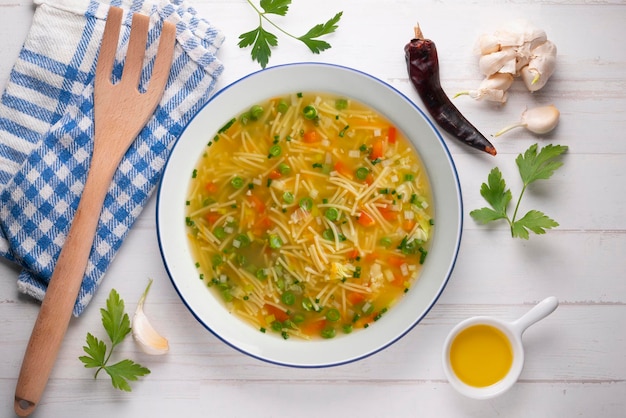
[{"x1": 186, "y1": 93, "x2": 434, "y2": 339}]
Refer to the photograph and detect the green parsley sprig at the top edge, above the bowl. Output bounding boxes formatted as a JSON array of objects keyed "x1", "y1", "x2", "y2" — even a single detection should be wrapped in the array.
[{"x1": 238, "y1": 0, "x2": 343, "y2": 68}]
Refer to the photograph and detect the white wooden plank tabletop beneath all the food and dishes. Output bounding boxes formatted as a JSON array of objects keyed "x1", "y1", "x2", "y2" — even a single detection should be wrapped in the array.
[{"x1": 0, "y1": 0, "x2": 626, "y2": 418}]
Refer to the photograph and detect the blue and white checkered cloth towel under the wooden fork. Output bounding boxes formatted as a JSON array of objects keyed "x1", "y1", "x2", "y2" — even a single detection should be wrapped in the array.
[{"x1": 0, "y1": 0, "x2": 223, "y2": 316}]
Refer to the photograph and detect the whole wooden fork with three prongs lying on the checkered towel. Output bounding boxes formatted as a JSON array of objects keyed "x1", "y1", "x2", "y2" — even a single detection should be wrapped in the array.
[{"x1": 14, "y1": 7, "x2": 176, "y2": 416}]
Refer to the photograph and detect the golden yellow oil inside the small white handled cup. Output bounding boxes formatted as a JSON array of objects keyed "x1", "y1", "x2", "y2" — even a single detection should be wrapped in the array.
[{"x1": 450, "y1": 324, "x2": 513, "y2": 387}]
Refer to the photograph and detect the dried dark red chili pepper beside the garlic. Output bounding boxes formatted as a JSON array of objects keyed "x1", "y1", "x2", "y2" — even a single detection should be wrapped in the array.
[{"x1": 404, "y1": 26, "x2": 496, "y2": 155}]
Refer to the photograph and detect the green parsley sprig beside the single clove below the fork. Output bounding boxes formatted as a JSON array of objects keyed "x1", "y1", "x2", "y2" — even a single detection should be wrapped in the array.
[{"x1": 79, "y1": 289, "x2": 150, "y2": 392}]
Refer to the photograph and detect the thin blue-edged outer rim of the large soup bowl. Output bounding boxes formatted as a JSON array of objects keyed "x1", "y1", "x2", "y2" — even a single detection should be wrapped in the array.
[{"x1": 155, "y1": 62, "x2": 463, "y2": 369}]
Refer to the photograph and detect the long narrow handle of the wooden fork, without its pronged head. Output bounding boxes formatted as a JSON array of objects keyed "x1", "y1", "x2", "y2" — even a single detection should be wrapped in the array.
[{"x1": 14, "y1": 161, "x2": 117, "y2": 416}]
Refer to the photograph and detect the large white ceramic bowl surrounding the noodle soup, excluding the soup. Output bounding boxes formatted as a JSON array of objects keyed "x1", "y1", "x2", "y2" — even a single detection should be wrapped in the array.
[{"x1": 157, "y1": 63, "x2": 463, "y2": 367}]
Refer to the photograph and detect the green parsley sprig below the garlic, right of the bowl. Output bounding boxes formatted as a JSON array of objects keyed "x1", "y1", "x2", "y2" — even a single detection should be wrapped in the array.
[{"x1": 470, "y1": 144, "x2": 568, "y2": 239}]
